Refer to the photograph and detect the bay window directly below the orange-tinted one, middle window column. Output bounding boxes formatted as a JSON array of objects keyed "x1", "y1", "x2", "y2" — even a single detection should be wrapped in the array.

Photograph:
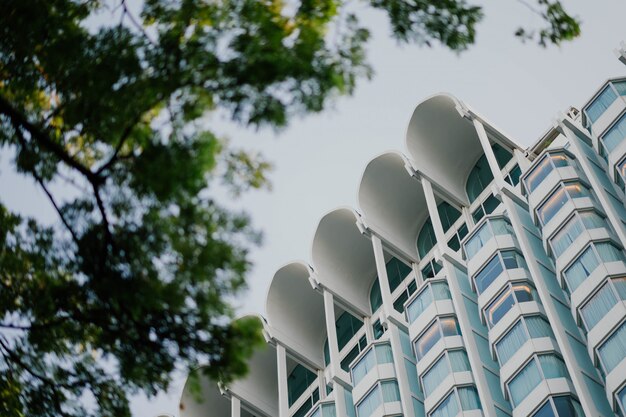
[{"x1": 496, "y1": 316, "x2": 554, "y2": 366}]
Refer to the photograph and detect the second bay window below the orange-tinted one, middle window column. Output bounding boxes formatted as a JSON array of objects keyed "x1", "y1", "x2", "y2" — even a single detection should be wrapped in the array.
[{"x1": 507, "y1": 354, "x2": 569, "y2": 407}]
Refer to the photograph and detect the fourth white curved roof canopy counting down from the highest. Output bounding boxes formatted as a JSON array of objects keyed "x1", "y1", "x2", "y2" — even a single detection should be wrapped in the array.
[{"x1": 265, "y1": 262, "x2": 326, "y2": 369}]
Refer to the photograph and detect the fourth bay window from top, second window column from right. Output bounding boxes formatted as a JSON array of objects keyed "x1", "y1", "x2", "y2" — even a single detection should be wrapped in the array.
[{"x1": 563, "y1": 242, "x2": 624, "y2": 294}]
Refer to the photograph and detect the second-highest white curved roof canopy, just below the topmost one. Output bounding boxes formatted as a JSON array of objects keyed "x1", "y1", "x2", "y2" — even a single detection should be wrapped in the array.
[{"x1": 358, "y1": 152, "x2": 428, "y2": 261}]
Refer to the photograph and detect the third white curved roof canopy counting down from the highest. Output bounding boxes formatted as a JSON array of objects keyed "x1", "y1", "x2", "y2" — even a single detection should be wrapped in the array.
[{"x1": 312, "y1": 208, "x2": 376, "y2": 315}]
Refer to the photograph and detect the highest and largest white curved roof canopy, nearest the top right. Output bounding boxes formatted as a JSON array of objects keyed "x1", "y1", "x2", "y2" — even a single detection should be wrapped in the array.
[{"x1": 406, "y1": 94, "x2": 484, "y2": 204}]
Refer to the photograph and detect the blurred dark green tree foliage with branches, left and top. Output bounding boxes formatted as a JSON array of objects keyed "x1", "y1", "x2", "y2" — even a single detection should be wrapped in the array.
[{"x1": 0, "y1": 0, "x2": 578, "y2": 417}]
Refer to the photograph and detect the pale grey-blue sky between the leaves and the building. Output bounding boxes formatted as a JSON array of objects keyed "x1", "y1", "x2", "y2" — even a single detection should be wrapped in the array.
[{"x1": 0, "y1": 0, "x2": 626, "y2": 417}]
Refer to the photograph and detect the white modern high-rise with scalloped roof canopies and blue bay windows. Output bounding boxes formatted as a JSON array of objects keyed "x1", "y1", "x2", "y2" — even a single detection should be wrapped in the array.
[{"x1": 180, "y1": 51, "x2": 626, "y2": 417}]
